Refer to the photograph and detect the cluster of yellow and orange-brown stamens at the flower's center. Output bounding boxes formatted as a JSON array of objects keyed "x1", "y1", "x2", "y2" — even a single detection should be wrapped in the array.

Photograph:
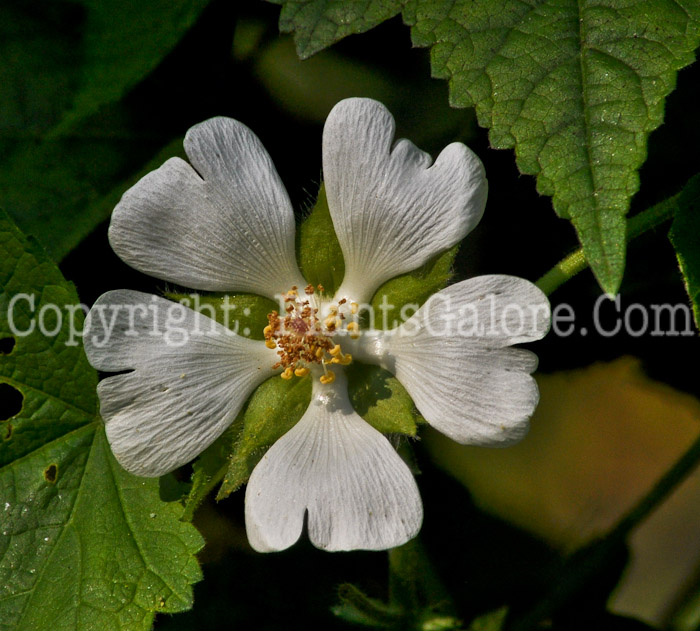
[{"x1": 263, "y1": 285, "x2": 357, "y2": 383}]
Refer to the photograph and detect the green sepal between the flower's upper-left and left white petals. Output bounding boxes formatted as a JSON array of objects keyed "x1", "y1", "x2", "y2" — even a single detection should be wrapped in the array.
[{"x1": 164, "y1": 291, "x2": 279, "y2": 340}]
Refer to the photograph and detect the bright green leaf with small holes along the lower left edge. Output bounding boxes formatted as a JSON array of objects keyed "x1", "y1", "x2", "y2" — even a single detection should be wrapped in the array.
[{"x1": 0, "y1": 212, "x2": 202, "y2": 631}]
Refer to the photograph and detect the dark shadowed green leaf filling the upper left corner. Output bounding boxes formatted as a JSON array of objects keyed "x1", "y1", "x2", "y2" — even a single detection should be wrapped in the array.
[{"x1": 0, "y1": 0, "x2": 208, "y2": 260}]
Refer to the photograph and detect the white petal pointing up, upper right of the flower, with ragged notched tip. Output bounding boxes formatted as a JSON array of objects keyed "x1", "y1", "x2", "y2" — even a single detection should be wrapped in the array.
[{"x1": 323, "y1": 98, "x2": 487, "y2": 302}]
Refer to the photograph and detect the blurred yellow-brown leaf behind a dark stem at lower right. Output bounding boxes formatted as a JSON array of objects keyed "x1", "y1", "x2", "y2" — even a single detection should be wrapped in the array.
[{"x1": 425, "y1": 357, "x2": 700, "y2": 623}]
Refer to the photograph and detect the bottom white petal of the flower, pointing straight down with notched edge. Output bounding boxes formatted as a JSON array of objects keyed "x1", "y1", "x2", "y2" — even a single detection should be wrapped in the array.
[{"x1": 245, "y1": 372, "x2": 423, "y2": 552}]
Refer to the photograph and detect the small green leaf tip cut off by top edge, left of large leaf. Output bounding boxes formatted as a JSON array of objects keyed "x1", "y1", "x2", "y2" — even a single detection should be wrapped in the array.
[{"x1": 270, "y1": 0, "x2": 402, "y2": 59}]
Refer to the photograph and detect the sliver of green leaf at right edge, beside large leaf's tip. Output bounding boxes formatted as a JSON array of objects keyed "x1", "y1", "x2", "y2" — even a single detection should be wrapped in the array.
[{"x1": 668, "y1": 175, "x2": 700, "y2": 329}]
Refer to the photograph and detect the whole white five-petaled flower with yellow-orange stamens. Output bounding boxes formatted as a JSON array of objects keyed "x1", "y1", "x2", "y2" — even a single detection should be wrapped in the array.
[{"x1": 85, "y1": 99, "x2": 549, "y2": 551}]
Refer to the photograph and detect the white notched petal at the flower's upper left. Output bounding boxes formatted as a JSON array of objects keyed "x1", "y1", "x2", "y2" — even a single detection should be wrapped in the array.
[{"x1": 109, "y1": 117, "x2": 304, "y2": 297}]
